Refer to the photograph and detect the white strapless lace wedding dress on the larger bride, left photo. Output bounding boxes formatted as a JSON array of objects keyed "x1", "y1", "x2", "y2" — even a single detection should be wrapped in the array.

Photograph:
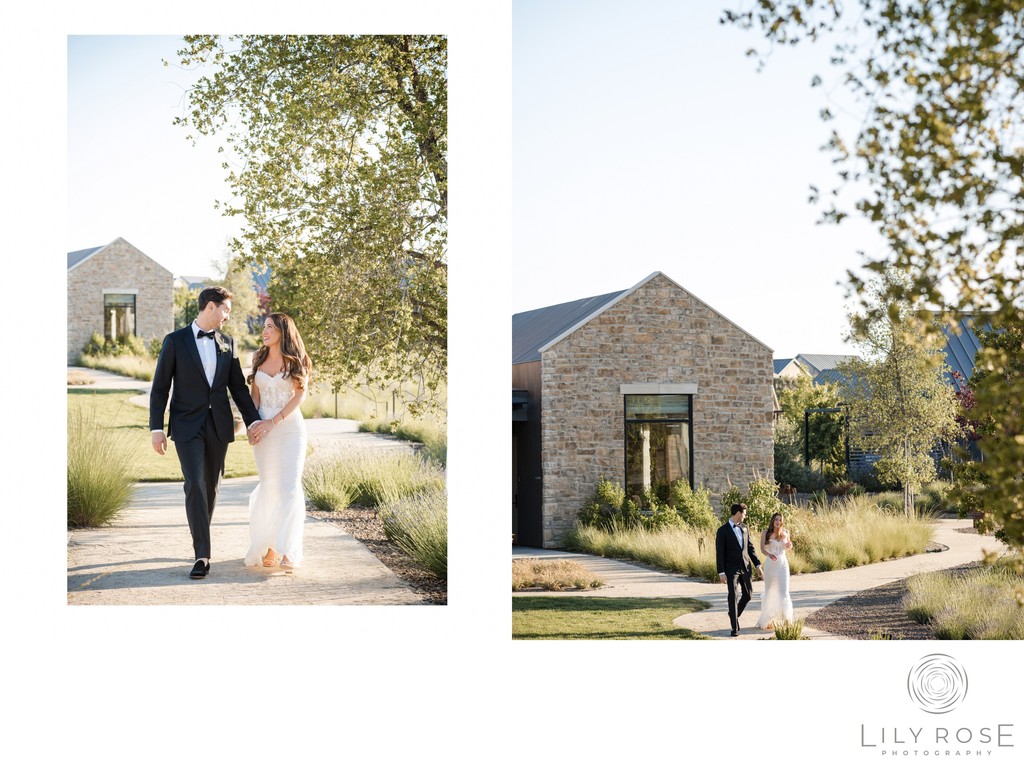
[{"x1": 246, "y1": 370, "x2": 306, "y2": 566}]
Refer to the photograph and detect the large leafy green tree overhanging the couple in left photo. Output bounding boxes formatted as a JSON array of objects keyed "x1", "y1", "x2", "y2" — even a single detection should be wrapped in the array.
[{"x1": 169, "y1": 35, "x2": 447, "y2": 407}]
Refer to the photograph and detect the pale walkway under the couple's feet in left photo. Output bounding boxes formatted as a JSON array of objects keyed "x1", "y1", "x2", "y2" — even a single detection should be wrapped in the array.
[{"x1": 68, "y1": 368, "x2": 423, "y2": 605}]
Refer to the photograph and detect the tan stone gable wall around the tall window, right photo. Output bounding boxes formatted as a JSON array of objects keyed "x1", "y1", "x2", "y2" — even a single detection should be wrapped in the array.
[{"x1": 541, "y1": 273, "x2": 774, "y2": 548}]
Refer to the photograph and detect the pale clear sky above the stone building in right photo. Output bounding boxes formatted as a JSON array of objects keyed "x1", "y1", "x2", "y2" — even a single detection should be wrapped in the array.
[{"x1": 510, "y1": 0, "x2": 879, "y2": 357}]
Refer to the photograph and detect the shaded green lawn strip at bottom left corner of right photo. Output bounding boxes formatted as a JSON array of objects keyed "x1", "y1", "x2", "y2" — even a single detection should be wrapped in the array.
[{"x1": 512, "y1": 596, "x2": 708, "y2": 639}]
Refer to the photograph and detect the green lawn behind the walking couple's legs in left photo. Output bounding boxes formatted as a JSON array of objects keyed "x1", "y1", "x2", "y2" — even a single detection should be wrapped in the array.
[{"x1": 68, "y1": 389, "x2": 256, "y2": 481}]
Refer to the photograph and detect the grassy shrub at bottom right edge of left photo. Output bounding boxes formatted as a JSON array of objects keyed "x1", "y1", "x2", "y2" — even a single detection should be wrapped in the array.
[{"x1": 380, "y1": 486, "x2": 447, "y2": 578}]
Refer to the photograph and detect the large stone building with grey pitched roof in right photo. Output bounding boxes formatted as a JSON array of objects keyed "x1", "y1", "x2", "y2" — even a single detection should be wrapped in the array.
[{"x1": 512, "y1": 271, "x2": 774, "y2": 548}]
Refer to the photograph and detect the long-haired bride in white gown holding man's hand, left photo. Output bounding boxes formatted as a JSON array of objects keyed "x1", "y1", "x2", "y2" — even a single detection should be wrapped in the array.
[{"x1": 246, "y1": 313, "x2": 312, "y2": 570}]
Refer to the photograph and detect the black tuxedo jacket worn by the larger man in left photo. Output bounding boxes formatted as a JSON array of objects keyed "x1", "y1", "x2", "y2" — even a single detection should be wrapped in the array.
[{"x1": 150, "y1": 323, "x2": 259, "y2": 443}]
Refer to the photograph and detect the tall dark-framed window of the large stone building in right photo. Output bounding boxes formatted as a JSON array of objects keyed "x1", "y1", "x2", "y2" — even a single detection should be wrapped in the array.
[{"x1": 624, "y1": 393, "x2": 693, "y2": 500}]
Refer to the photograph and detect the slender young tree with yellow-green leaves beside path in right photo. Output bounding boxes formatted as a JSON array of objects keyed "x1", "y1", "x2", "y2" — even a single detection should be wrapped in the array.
[{"x1": 840, "y1": 272, "x2": 961, "y2": 516}]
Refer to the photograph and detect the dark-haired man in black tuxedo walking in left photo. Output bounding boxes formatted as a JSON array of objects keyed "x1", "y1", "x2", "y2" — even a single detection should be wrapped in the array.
[{"x1": 150, "y1": 287, "x2": 259, "y2": 580}]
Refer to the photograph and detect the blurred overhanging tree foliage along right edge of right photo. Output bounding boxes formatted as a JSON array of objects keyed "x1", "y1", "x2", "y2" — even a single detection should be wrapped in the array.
[{"x1": 722, "y1": 0, "x2": 1024, "y2": 547}]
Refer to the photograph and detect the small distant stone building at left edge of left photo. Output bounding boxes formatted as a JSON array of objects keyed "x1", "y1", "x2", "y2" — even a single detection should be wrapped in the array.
[{"x1": 68, "y1": 238, "x2": 174, "y2": 364}]
